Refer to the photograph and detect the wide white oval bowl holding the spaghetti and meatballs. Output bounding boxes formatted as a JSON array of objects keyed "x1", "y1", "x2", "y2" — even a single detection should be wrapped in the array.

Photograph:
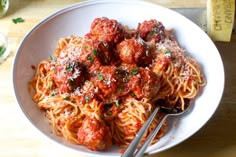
[{"x1": 13, "y1": 0, "x2": 224, "y2": 157}]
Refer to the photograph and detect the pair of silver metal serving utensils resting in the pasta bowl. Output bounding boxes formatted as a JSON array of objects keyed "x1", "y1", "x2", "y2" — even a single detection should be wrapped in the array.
[{"x1": 121, "y1": 105, "x2": 190, "y2": 157}]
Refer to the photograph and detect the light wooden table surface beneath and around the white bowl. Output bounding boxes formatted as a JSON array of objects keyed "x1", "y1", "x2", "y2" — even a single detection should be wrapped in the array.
[{"x1": 0, "y1": 0, "x2": 236, "y2": 157}]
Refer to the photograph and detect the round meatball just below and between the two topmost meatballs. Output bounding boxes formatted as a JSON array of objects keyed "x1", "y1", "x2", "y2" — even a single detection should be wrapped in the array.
[{"x1": 117, "y1": 38, "x2": 151, "y2": 65}]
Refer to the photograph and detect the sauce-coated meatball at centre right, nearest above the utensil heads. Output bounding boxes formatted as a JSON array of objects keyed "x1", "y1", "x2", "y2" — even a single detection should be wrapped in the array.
[{"x1": 128, "y1": 68, "x2": 160, "y2": 98}]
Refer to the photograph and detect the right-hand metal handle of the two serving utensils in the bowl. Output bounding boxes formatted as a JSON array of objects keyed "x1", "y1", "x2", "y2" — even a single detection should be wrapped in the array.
[{"x1": 134, "y1": 114, "x2": 168, "y2": 157}]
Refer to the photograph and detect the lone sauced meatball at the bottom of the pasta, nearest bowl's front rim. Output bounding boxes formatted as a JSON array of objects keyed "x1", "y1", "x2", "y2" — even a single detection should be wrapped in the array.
[{"x1": 77, "y1": 116, "x2": 112, "y2": 150}]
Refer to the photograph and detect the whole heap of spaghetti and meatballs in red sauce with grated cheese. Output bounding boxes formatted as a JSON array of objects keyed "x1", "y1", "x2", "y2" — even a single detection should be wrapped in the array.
[{"x1": 29, "y1": 17, "x2": 206, "y2": 150}]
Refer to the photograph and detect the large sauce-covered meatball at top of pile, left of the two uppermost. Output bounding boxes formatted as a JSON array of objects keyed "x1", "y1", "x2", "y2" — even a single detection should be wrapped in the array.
[{"x1": 90, "y1": 17, "x2": 124, "y2": 43}]
